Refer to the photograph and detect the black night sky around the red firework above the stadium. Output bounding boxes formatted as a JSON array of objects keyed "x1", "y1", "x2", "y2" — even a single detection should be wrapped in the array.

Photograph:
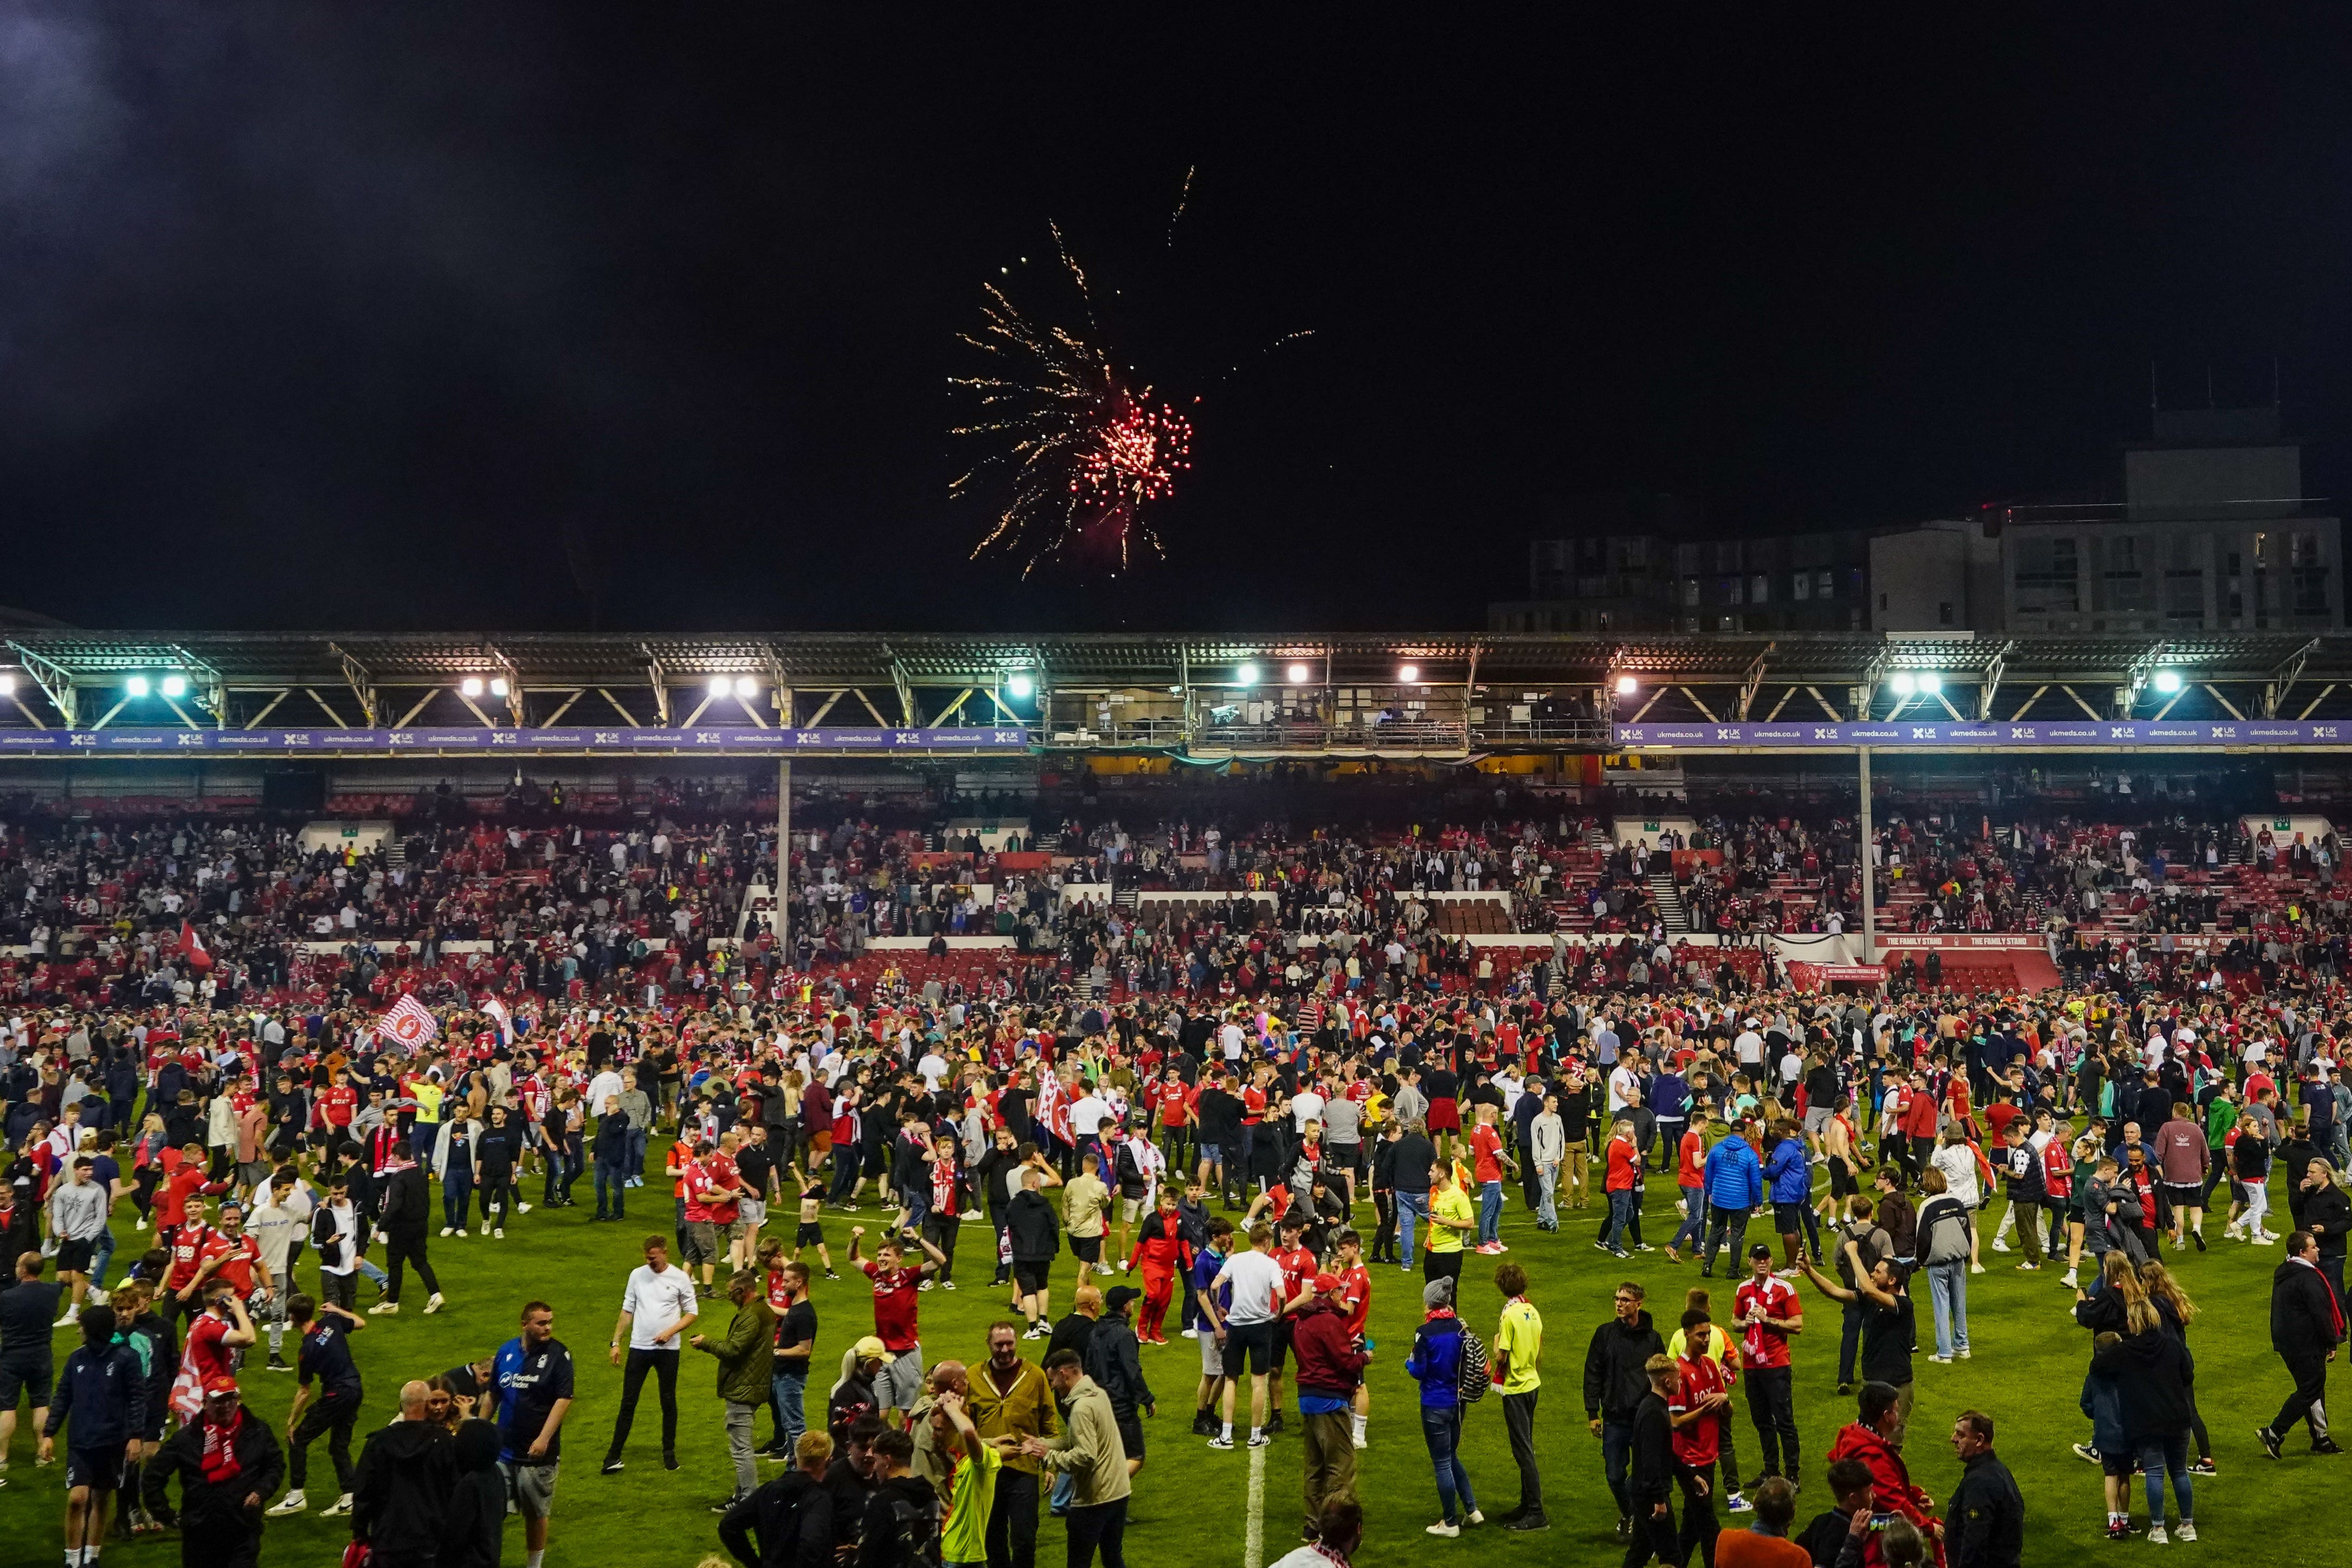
[{"x1": 0, "y1": 0, "x2": 2352, "y2": 630}]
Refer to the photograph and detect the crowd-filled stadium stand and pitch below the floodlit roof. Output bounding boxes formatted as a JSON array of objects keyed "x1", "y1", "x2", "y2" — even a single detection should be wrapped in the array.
[{"x1": 0, "y1": 773, "x2": 2352, "y2": 1568}]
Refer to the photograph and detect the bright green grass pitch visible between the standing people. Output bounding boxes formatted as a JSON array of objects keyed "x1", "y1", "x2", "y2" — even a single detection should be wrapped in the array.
[{"x1": 0, "y1": 1150, "x2": 2352, "y2": 1568}]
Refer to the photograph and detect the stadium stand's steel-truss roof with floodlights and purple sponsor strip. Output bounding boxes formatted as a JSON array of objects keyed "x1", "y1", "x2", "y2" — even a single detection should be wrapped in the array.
[{"x1": 0, "y1": 628, "x2": 2352, "y2": 759}]
